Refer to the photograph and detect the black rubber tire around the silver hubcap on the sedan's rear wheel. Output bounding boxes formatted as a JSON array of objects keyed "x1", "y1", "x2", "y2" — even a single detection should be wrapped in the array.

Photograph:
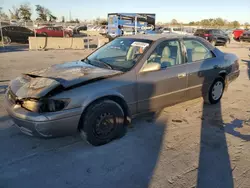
[{"x1": 207, "y1": 77, "x2": 225, "y2": 104}]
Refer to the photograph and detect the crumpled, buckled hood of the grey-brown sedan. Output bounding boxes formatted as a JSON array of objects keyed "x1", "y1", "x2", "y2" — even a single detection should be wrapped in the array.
[{"x1": 9, "y1": 61, "x2": 122, "y2": 99}]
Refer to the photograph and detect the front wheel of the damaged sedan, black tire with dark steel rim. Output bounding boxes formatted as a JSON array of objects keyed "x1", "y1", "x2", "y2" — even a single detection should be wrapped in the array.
[{"x1": 79, "y1": 100, "x2": 126, "y2": 146}]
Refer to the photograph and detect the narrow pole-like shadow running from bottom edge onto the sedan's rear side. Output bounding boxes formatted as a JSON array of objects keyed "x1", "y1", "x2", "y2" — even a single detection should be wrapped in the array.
[{"x1": 197, "y1": 56, "x2": 234, "y2": 188}]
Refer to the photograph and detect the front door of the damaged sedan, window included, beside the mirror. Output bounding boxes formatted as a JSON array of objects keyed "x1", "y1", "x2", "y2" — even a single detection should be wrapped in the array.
[{"x1": 137, "y1": 40, "x2": 187, "y2": 113}]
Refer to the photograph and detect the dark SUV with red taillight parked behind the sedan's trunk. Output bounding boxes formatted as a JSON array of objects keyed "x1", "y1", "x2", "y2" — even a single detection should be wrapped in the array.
[{"x1": 194, "y1": 29, "x2": 230, "y2": 46}]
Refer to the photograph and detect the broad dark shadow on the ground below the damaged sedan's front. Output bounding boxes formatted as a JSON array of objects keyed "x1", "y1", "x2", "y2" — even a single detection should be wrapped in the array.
[{"x1": 0, "y1": 81, "x2": 167, "y2": 188}]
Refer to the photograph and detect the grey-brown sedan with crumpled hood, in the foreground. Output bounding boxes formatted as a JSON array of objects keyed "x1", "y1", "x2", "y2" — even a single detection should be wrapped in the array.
[{"x1": 4, "y1": 35, "x2": 240, "y2": 145}]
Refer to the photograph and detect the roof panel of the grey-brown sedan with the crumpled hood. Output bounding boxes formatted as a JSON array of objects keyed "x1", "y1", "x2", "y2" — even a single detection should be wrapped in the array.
[{"x1": 121, "y1": 34, "x2": 198, "y2": 41}]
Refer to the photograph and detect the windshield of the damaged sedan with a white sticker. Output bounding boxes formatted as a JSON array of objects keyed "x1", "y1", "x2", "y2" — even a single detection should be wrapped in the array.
[{"x1": 83, "y1": 38, "x2": 152, "y2": 71}]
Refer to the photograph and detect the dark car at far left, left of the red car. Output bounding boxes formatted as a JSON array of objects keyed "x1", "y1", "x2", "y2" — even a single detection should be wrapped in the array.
[{"x1": 0, "y1": 25, "x2": 37, "y2": 44}]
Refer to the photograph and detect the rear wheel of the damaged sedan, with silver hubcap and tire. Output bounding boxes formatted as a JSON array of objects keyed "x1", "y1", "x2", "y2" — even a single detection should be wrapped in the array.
[{"x1": 208, "y1": 77, "x2": 225, "y2": 104}]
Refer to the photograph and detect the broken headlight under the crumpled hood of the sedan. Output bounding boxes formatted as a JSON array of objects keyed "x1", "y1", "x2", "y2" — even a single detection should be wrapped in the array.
[{"x1": 22, "y1": 99, "x2": 69, "y2": 113}]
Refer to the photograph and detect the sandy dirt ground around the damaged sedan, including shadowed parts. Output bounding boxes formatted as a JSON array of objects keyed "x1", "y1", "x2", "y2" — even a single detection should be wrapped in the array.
[{"x1": 0, "y1": 43, "x2": 250, "y2": 188}]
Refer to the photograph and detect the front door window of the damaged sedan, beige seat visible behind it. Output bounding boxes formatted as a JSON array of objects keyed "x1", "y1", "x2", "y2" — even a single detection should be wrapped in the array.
[{"x1": 147, "y1": 40, "x2": 182, "y2": 68}]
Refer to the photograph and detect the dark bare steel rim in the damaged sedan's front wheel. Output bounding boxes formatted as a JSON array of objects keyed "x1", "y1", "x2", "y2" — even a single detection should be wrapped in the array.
[{"x1": 95, "y1": 113, "x2": 115, "y2": 138}]
